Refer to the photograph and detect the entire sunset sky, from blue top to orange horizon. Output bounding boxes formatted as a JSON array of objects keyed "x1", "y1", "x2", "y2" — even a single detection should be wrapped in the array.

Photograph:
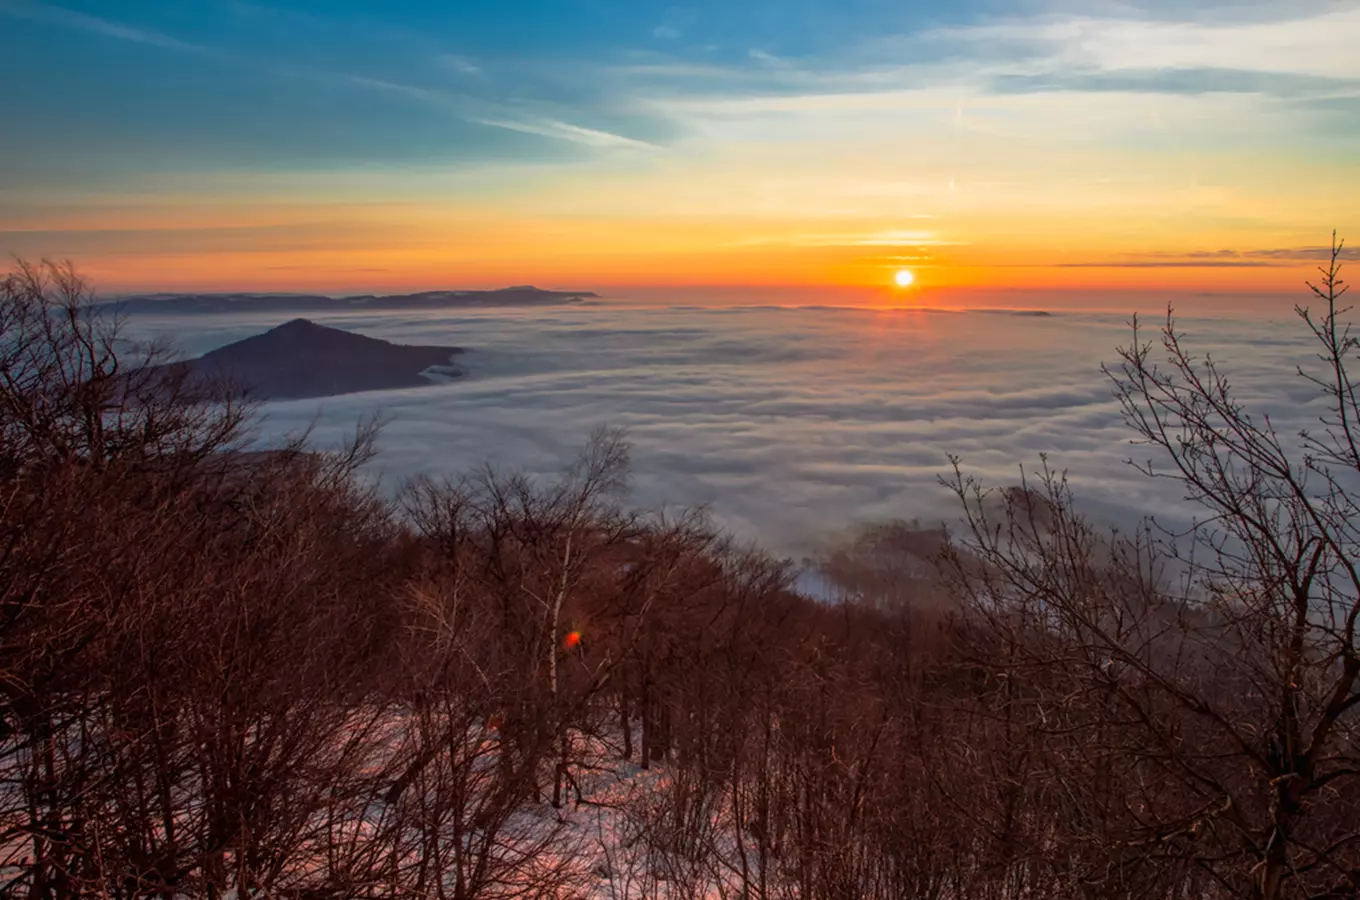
[{"x1": 0, "y1": 0, "x2": 1360, "y2": 296}]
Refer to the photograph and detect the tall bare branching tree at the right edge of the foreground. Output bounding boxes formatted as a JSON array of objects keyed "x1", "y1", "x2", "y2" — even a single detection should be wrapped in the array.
[{"x1": 952, "y1": 233, "x2": 1360, "y2": 900}]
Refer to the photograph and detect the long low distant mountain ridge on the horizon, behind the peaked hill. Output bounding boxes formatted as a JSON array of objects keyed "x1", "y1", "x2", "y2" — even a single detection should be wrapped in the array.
[{"x1": 99, "y1": 290, "x2": 598, "y2": 319}]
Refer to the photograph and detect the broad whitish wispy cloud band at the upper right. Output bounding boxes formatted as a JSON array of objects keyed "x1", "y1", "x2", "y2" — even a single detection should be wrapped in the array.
[{"x1": 630, "y1": 0, "x2": 1360, "y2": 125}]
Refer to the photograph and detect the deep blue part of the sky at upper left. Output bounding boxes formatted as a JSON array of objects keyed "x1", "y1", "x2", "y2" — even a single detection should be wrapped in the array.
[{"x1": 0, "y1": 0, "x2": 1022, "y2": 175}]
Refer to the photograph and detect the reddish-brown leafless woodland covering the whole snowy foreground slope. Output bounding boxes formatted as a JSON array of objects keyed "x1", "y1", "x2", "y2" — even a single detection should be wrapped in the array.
[{"x1": 0, "y1": 247, "x2": 1360, "y2": 900}]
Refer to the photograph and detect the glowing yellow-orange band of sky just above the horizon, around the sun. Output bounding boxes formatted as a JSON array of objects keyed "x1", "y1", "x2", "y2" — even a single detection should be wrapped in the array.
[{"x1": 19, "y1": 139, "x2": 1360, "y2": 299}]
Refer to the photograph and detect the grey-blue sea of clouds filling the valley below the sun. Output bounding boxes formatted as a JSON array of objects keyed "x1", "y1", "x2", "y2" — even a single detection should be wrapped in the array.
[{"x1": 129, "y1": 300, "x2": 1322, "y2": 556}]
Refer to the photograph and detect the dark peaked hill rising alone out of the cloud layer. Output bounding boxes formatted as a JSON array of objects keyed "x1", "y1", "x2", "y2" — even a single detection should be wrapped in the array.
[{"x1": 163, "y1": 318, "x2": 462, "y2": 400}]
